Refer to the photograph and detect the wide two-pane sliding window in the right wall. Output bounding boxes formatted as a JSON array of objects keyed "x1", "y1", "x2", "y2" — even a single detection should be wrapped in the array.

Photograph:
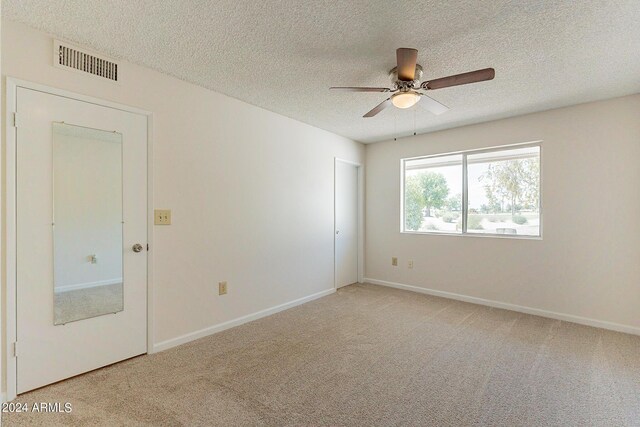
[{"x1": 402, "y1": 143, "x2": 541, "y2": 237}]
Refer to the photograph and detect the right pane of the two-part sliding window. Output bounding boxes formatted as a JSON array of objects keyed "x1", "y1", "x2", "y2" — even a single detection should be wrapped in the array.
[{"x1": 467, "y1": 147, "x2": 540, "y2": 236}]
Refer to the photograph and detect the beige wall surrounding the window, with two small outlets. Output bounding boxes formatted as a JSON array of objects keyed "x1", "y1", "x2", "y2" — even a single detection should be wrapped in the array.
[{"x1": 365, "y1": 95, "x2": 640, "y2": 332}]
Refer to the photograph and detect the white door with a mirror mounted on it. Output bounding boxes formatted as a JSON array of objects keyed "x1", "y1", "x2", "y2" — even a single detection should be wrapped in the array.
[{"x1": 16, "y1": 88, "x2": 147, "y2": 393}]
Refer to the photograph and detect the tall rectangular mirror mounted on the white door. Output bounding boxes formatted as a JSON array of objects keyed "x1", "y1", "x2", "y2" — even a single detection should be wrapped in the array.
[{"x1": 53, "y1": 123, "x2": 124, "y2": 325}]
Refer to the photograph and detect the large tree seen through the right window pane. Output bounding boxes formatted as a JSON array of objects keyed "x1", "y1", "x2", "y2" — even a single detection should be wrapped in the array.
[{"x1": 480, "y1": 159, "x2": 540, "y2": 216}]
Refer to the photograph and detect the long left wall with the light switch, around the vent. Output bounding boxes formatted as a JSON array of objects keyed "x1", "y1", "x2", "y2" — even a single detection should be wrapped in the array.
[{"x1": 2, "y1": 21, "x2": 364, "y2": 362}]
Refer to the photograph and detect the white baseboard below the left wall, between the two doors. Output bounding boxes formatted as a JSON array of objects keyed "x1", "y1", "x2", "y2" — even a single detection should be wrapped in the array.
[{"x1": 149, "y1": 288, "x2": 336, "y2": 353}]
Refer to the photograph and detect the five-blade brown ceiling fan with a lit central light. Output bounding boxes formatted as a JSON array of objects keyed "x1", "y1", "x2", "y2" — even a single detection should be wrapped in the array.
[{"x1": 330, "y1": 47, "x2": 496, "y2": 117}]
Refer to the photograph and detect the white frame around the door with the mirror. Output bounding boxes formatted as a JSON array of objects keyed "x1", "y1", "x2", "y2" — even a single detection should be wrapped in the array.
[{"x1": 0, "y1": 77, "x2": 154, "y2": 401}]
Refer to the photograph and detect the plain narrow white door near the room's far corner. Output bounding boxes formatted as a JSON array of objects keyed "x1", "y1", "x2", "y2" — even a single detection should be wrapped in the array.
[{"x1": 335, "y1": 160, "x2": 358, "y2": 288}]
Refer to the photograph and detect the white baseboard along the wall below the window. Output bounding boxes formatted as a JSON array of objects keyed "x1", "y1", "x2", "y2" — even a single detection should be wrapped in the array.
[{"x1": 364, "y1": 278, "x2": 640, "y2": 335}]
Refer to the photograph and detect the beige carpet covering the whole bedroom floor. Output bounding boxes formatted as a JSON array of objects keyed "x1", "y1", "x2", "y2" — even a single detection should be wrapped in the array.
[{"x1": 3, "y1": 285, "x2": 640, "y2": 426}]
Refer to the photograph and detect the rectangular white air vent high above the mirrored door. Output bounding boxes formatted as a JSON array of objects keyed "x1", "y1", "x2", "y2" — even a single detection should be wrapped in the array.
[{"x1": 53, "y1": 40, "x2": 118, "y2": 82}]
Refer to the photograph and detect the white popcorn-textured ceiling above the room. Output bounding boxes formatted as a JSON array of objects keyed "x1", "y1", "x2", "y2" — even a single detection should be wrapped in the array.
[{"x1": 2, "y1": 0, "x2": 640, "y2": 142}]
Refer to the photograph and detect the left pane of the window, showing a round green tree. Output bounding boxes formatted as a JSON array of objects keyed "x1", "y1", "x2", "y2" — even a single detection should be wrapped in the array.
[{"x1": 404, "y1": 154, "x2": 462, "y2": 233}]
